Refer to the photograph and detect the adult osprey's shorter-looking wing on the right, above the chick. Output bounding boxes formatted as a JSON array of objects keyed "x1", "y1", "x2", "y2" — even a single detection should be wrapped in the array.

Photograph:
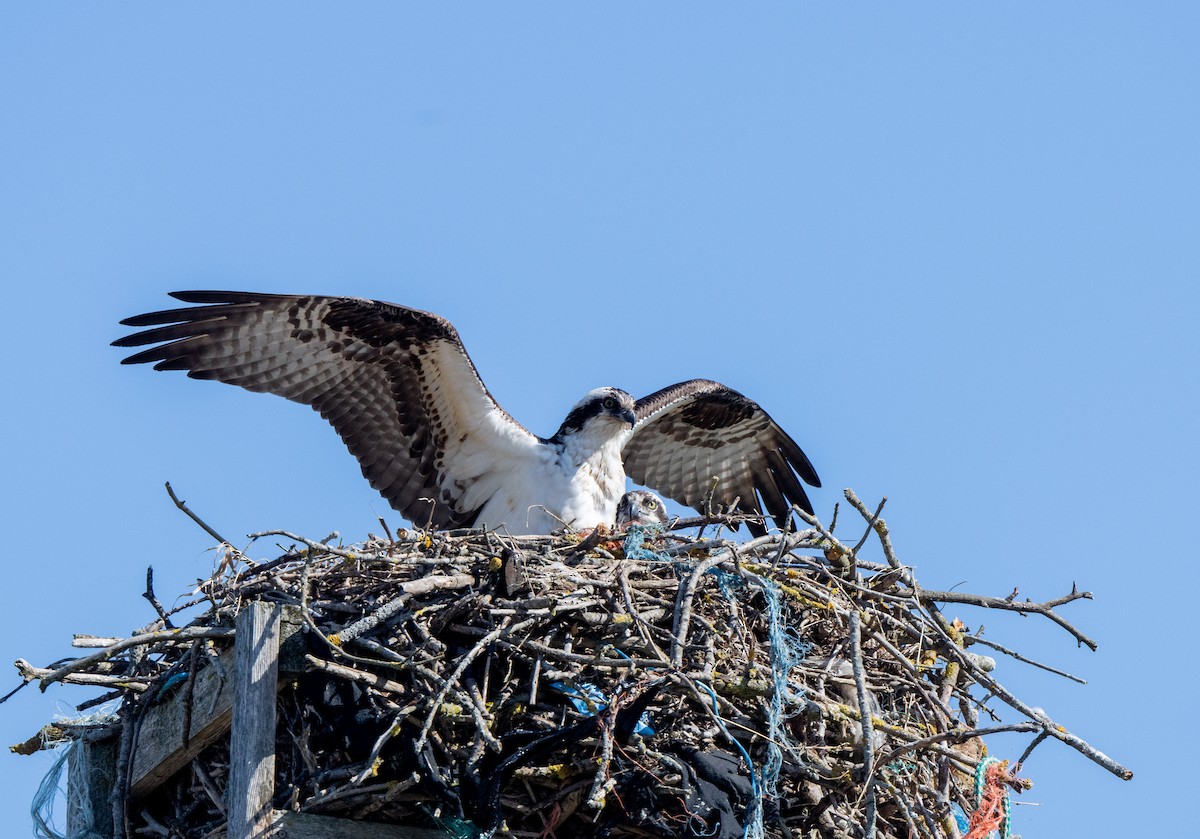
[{"x1": 623, "y1": 379, "x2": 821, "y2": 535}]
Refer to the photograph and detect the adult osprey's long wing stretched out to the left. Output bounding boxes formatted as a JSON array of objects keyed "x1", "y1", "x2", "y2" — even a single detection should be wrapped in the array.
[{"x1": 113, "y1": 292, "x2": 539, "y2": 527}]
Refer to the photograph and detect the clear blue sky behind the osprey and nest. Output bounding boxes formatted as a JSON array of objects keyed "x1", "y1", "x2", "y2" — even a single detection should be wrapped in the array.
[{"x1": 0, "y1": 2, "x2": 1200, "y2": 837}]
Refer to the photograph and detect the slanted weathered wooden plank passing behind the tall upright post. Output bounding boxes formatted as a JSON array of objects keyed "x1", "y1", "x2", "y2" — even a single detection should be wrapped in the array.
[{"x1": 130, "y1": 606, "x2": 304, "y2": 798}]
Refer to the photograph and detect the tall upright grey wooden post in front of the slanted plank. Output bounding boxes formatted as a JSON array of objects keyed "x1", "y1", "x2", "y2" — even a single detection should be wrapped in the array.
[{"x1": 226, "y1": 601, "x2": 282, "y2": 839}]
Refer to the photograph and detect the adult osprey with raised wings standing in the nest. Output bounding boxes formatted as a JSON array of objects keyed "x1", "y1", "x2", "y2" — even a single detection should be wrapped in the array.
[{"x1": 113, "y1": 292, "x2": 821, "y2": 534}]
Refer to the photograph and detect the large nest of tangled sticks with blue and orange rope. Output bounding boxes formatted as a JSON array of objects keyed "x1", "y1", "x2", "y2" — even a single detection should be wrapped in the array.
[{"x1": 18, "y1": 493, "x2": 1126, "y2": 839}]
